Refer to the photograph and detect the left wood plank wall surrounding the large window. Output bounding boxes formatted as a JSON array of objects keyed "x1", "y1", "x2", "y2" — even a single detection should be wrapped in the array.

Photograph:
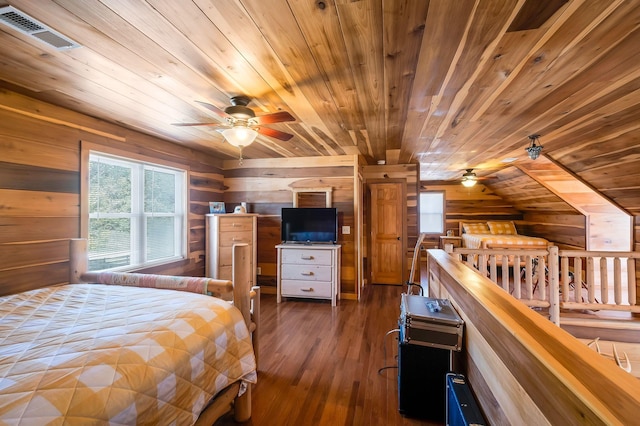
[{"x1": 0, "y1": 90, "x2": 223, "y2": 294}]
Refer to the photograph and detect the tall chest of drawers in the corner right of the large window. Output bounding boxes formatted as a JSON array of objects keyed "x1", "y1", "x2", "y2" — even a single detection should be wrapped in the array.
[{"x1": 205, "y1": 213, "x2": 258, "y2": 286}]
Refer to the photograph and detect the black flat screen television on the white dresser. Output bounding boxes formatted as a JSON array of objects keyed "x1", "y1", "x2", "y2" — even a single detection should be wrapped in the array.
[{"x1": 281, "y1": 207, "x2": 338, "y2": 244}]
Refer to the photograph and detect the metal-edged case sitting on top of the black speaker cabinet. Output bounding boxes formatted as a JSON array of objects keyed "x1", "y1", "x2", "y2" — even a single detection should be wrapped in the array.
[{"x1": 399, "y1": 293, "x2": 464, "y2": 351}]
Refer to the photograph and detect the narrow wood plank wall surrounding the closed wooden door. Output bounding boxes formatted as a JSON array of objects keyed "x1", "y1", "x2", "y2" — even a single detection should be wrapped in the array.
[{"x1": 362, "y1": 164, "x2": 418, "y2": 281}]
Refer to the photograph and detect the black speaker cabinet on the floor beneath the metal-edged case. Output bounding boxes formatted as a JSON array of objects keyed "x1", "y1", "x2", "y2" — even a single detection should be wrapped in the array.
[{"x1": 398, "y1": 339, "x2": 452, "y2": 423}]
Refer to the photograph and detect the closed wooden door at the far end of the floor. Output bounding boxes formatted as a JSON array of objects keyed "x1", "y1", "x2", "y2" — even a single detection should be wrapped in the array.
[{"x1": 370, "y1": 183, "x2": 406, "y2": 285}]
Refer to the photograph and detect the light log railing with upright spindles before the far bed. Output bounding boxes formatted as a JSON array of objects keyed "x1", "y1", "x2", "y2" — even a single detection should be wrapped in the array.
[{"x1": 447, "y1": 246, "x2": 640, "y2": 325}]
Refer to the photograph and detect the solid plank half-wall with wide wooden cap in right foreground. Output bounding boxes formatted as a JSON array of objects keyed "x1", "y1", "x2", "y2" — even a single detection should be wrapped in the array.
[{"x1": 427, "y1": 250, "x2": 640, "y2": 425}]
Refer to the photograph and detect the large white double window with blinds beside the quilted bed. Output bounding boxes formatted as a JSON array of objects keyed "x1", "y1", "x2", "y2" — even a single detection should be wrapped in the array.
[{"x1": 88, "y1": 152, "x2": 186, "y2": 271}]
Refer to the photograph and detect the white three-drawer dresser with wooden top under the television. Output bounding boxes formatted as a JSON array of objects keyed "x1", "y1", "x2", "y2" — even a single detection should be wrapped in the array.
[{"x1": 276, "y1": 244, "x2": 341, "y2": 306}]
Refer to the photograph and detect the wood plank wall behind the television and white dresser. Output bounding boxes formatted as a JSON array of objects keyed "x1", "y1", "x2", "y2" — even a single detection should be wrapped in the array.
[{"x1": 223, "y1": 155, "x2": 359, "y2": 298}]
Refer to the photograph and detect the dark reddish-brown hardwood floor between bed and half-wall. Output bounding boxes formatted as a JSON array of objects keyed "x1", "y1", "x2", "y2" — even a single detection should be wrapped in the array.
[{"x1": 216, "y1": 285, "x2": 437, "y2": 426}]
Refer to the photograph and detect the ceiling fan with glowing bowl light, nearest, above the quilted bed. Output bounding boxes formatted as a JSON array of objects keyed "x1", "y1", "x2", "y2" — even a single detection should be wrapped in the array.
[{"x1": 174, "y1": 95, "x2": 295, "y2": 149}]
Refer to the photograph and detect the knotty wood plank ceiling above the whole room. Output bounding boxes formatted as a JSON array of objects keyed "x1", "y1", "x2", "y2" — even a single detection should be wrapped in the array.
[{"x1": 0, "y1": 0, "x2": 640, "y2": 195}]
